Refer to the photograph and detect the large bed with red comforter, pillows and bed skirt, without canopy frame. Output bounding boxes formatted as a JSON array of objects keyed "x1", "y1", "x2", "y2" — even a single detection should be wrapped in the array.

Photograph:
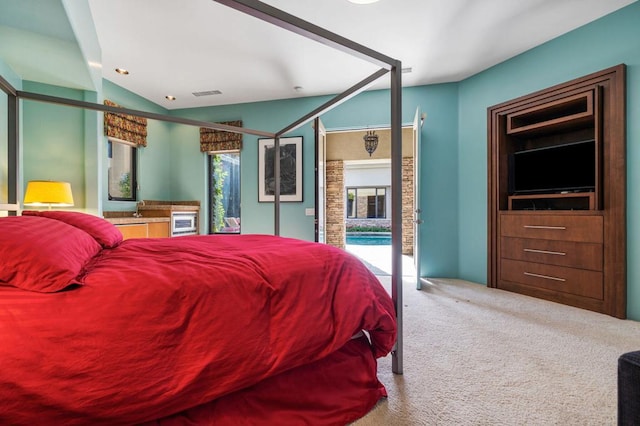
[{"x1": 0, "y1": 211, "x2": 397, "y2": 425}]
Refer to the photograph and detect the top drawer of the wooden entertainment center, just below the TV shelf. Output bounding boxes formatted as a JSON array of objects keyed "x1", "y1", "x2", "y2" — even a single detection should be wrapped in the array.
[{"x1": 500, "y1": 214, "x2": 603, "y2": 243}]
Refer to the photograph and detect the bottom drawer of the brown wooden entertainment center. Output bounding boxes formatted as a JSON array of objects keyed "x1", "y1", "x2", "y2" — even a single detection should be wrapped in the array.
[{"x1": 500, "y1": 259, "x2": 604, "y2": 300}]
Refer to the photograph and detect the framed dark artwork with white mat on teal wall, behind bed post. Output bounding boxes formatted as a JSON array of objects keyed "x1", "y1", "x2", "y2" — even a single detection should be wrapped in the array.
[{"x1": 258, "y1": 136, "x2": 302, "y2": 202}]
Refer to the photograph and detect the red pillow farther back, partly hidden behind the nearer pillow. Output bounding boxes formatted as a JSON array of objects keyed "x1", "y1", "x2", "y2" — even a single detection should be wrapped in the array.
[{"x1": 22, "y1": 210, "x2": 122, "y2": 248}]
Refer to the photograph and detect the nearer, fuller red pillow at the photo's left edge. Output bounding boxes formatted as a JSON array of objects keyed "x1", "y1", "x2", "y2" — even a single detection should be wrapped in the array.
[{"x1": 0, "y1": 216, "x2": 100, "y2": 293}]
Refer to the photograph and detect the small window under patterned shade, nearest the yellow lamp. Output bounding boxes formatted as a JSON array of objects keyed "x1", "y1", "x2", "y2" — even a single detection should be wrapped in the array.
[{"x1": 107, "y1": 138, "x2": 138, "y2": 201}]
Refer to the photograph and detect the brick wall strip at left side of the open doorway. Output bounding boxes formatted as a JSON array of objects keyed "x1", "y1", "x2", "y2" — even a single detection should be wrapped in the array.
[{"x1": 325, "y1": 160, "x2": 345, "y2": 249}]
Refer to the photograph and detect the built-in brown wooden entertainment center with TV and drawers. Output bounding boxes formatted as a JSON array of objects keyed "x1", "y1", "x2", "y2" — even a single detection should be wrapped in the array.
[{"x1": 488, "y1": 64, "x2": 626, "y2": 318}]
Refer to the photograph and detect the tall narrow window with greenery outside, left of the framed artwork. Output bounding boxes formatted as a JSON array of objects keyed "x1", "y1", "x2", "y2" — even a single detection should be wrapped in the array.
[{"x1": 209, "y1": 152, "x2": 240, "y2": 234}]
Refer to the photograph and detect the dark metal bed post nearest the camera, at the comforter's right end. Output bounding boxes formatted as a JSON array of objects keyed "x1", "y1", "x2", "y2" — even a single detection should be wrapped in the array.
[{"x1": 391, "y1": 61, "x2": 403, "y2": 374}]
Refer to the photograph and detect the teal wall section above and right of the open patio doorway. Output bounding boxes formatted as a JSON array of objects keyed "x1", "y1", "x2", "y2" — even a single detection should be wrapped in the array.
[{"x1": 322, "y1": 86, "x2": 459, "y2": 277}]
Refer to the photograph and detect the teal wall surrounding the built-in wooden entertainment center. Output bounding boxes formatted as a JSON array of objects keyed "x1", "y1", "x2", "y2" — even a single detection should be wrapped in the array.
[{"x1": 458, "y1": 2, "x2": 640, "y2": 319}]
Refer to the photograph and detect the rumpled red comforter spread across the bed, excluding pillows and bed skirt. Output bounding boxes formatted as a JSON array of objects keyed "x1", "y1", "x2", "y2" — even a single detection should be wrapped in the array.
[{"x1": 0, "y1": 218, "x2": 396, "y2": 425}]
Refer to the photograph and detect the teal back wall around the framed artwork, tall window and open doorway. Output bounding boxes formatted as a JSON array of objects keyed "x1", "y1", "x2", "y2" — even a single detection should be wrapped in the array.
[{"x1": 171, "y1": 84, "x2": 458, "y2": 277}]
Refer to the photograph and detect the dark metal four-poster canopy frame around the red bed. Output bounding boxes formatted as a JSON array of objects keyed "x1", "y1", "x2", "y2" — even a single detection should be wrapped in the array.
[{"x1": 0, "y1": 0, "x2": 403, "y2": 374}]
